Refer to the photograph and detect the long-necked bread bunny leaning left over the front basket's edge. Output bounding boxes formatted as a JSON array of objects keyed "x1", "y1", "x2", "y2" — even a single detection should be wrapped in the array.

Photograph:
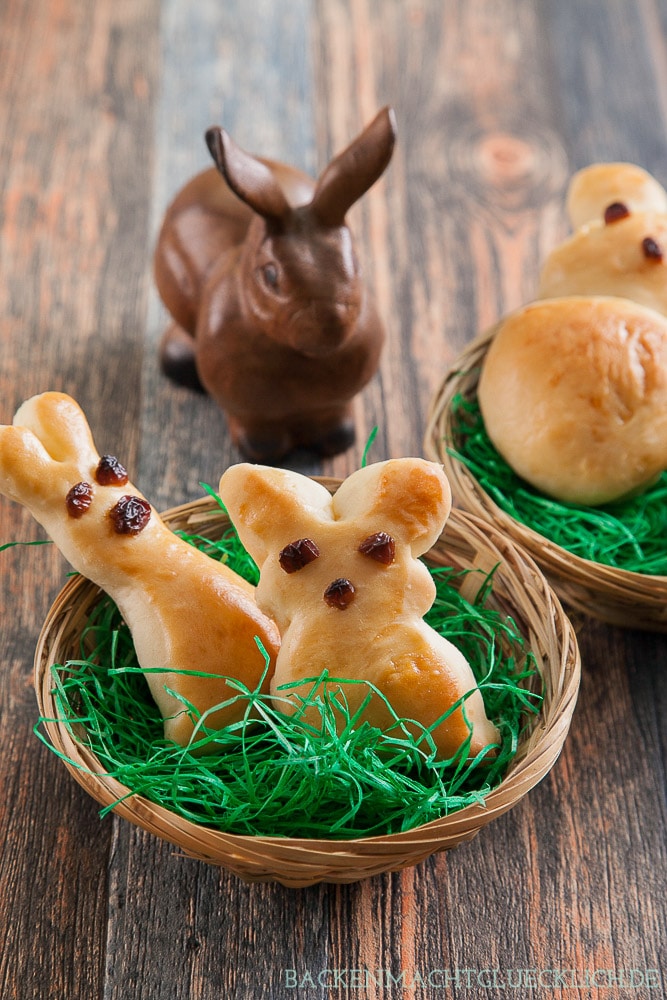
[{"x1": 0, "y1": 392, "x2": 280, "y2": 746}]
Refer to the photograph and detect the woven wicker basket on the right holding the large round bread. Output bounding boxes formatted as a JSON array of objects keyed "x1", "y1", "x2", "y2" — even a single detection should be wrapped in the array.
[{"x1": 424, "y1": 326, "x2": 667, "y2": 632}]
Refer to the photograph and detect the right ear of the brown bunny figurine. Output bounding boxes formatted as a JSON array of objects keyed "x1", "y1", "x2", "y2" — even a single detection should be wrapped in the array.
[{"x1": 310, "y1": 107, "x2": 396, "y2": 226}]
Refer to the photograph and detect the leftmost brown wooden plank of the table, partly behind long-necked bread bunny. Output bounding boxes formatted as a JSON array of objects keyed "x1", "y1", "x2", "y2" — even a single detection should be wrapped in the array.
[{"x1": 0, "y1": 0, "x2": 158, "y2": 1000}]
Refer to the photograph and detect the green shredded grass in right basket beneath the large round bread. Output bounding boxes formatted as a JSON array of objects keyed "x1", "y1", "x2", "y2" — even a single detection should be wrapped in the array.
[{"x1": 448, "y1": 394, "x2": 667, "y2": 576}]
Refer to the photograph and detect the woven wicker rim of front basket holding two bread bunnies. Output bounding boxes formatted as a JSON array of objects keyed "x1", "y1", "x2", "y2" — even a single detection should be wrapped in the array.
[{"x1": 34, "y1": 488, "x2": 581, "y2": 884}]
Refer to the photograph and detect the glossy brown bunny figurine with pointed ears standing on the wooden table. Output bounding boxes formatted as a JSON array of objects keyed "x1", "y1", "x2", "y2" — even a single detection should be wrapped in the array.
[{"x1": 155, "y1": 108, "x2": 396, "y2": 463}]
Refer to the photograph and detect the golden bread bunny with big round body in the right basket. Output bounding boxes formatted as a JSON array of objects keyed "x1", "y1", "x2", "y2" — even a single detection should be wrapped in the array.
[{"x1": 478, "y1": 163, "x2": 667, "y2": 505}]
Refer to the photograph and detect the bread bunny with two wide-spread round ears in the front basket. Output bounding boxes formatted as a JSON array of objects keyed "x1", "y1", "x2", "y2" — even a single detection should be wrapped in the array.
[{"x1": 220, "y1": 458, "x2": 499, "y2": 758}]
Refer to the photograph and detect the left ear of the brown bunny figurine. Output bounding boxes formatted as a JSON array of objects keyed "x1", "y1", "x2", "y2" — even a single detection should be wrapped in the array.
[{"x1": 206, "y1": 125, "x2": 291, "y2": 220}]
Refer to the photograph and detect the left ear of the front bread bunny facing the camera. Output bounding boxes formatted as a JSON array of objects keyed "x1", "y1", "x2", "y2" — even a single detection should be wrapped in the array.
[{"x1": 219, "y1": 462, "x2": 333, "y2": 568}]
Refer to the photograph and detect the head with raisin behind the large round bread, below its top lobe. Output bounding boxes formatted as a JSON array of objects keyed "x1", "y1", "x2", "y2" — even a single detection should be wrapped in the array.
[{"x1": 538, "y1": 212, "x2": 667, "y2": 315}]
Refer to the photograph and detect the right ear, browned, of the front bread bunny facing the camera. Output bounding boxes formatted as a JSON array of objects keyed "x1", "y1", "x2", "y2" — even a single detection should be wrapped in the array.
[{"x1": 333, "y1": 458, "x2": 452, "y2": 556}]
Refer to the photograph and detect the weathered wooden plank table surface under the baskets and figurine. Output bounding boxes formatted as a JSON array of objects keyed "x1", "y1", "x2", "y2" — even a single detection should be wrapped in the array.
[{"x1": 0, "y1": 0, "x2": 667, "y2": 1000}]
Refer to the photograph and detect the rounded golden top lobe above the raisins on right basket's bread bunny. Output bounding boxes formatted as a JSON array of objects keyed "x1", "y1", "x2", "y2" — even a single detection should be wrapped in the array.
[{"x1": 566, "y1": 163, "x2": 667, "y2": 229}]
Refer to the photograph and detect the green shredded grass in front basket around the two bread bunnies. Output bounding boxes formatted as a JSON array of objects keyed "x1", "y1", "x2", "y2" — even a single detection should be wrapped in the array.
[{"x1": 35, "y1": 512, "x2": 542, "y2": 839}]
